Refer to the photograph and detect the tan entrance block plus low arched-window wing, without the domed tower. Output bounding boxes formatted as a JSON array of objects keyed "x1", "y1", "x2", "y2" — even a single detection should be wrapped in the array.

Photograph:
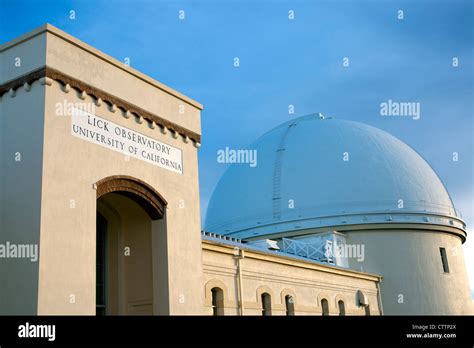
[{"x1": 0, "y1": 25, "x2": 464, "y2": 315}]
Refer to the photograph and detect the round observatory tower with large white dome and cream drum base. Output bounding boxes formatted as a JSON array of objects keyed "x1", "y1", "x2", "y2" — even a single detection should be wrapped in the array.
[{"x1": 205, "y1": 114, "x2": 472, "y2": 314}]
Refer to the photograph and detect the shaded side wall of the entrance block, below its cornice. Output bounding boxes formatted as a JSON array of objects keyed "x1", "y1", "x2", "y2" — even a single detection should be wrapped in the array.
[{"x1": 0, "y1": 77, "x2": 45, "y2": 314}]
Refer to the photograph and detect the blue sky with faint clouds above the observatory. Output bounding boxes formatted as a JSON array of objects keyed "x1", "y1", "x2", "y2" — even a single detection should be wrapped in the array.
[{"x1": 0, "y1": 0, "x2": 474, "y2": 289}]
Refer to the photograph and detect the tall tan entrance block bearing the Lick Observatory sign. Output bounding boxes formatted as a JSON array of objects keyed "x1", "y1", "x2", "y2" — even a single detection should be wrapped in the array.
[{"x1": 0, "y1": 25, "x2": 203, "y2": 314}]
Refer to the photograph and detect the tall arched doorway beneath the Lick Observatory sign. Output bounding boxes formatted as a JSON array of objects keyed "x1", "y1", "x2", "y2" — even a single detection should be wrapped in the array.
[{"x1": 96, "y1": 176, "x2": 166, "y2": 315}]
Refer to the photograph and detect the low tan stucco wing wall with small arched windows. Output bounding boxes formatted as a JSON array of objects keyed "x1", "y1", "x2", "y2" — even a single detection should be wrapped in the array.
[{"x1": 203, "y1": 241, "x2": 380, "y2": 315}]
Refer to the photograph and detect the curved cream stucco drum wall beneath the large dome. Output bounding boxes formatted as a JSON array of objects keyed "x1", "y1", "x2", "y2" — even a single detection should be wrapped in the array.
[{"x1": 345, "y1": 229, "x2": 474, "y2": 315}]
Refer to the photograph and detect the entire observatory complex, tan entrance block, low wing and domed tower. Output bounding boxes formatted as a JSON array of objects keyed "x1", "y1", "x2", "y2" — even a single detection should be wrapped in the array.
[{"x1": 0, "y1": 25, "x2": 473, "y2": 315}]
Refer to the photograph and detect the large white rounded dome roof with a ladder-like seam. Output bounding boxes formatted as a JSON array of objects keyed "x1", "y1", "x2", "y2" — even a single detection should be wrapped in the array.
[{"x1": 205, "y1": 114, "x2": 465, "y2": 239}]
